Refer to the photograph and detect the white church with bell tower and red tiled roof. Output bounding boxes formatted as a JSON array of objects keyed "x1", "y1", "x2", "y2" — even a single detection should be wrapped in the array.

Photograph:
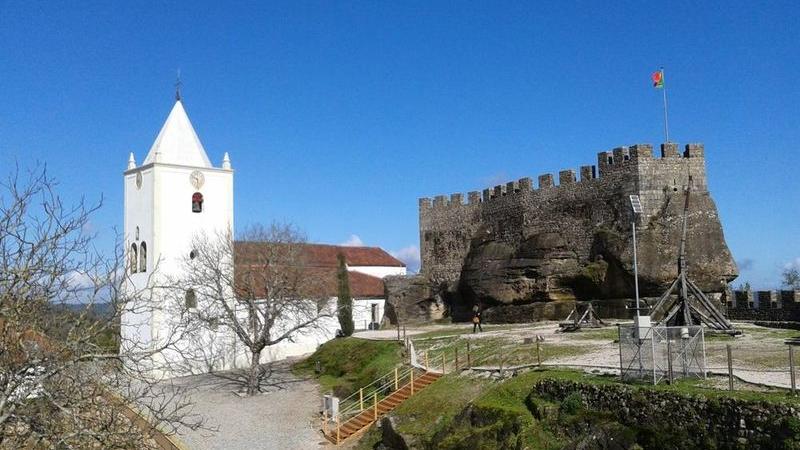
[{"x1": 121, "y1": 95, "x2": 406, "y2": 377}]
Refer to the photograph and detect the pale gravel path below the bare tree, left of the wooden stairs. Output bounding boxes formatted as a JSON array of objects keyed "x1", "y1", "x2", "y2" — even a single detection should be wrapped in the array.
[{"x1": 166, "y1": 361, "x2": 327, "y2": 450}]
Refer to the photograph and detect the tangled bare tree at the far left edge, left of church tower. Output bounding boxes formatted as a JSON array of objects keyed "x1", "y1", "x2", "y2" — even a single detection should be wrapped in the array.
[{"x1": 0, "y1": 167, "x2": 202, "y2": 448}]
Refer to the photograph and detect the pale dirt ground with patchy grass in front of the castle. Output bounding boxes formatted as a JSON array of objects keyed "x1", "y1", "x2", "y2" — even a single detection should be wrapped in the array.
[{"x1": 356, "y1": 321, "x2": 800, "y2": 387}]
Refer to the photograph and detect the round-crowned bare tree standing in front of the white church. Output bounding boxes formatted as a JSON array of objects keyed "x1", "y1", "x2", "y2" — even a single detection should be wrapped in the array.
[{"x1": 176, "y1": 223, "x2": 336, "y2": 395}]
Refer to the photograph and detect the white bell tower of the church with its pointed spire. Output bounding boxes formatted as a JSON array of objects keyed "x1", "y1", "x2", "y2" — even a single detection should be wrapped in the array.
[{"x1": 121, "y1": 98, "x2": 233, "y2": 376}]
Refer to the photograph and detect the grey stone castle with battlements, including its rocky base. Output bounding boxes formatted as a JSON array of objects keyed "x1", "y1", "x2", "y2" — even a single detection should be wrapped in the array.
[{"x1": 388, "y1": 143, "x2": 738, "y2": 320}]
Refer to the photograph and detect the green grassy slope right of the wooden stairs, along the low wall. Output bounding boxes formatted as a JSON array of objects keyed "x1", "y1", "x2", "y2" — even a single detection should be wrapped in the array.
[{"x1": 357, "y1": 369, "x2": 800, "y2": 450}]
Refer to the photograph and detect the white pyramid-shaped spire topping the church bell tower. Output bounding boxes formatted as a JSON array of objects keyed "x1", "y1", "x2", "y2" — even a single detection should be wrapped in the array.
[{"x1": 144, "y1": 100, "x2": 211, "y2": 167}]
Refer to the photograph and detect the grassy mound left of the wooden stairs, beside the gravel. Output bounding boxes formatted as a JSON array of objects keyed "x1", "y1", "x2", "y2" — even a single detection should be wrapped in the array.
[{"x1": 293, "y1": 337, "x2": 403, "y2": 398}]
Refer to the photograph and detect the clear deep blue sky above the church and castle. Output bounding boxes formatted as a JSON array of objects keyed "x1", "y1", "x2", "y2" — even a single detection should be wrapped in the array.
[{"x1": 0, "y1": 0, "x2": 800, "y2": 287}]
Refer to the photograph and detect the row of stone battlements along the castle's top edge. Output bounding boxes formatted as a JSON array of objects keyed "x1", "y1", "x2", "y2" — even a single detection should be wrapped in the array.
[{"x1": 419, "y1": 142, "x2": 705, "y2": 211}]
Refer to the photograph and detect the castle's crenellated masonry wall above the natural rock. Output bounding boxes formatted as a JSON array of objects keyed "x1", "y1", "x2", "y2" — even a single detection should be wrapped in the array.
[{"x1": 419, "y1": 143, "x2": 707, "y2": 280}]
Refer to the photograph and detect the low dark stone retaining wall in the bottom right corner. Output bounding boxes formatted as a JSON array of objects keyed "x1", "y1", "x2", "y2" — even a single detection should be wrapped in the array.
[{"x1": 529, "y1": 379, "x2": 800, "y2": 448}]
